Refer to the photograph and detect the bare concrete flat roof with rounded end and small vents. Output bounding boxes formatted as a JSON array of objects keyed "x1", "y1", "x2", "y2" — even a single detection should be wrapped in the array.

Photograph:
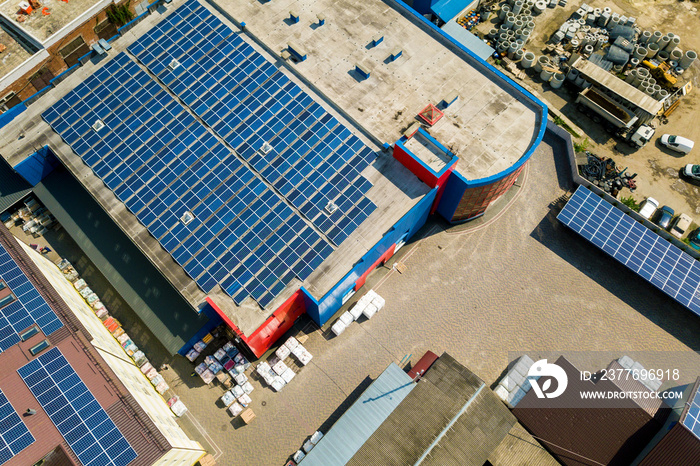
[{"x1": 217, "y1": 0, "x2": 539, "y2": 179}]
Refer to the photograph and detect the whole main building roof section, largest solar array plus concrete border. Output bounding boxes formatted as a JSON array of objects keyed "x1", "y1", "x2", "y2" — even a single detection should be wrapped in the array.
[{"x1": 3, "y1": 1, "x2": 430, "y2": 334}]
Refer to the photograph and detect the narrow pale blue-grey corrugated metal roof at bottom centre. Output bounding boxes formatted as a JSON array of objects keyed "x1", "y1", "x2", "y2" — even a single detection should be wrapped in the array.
[{"x1": 300, "y1": 363, "x2": 416, "y2": 466}]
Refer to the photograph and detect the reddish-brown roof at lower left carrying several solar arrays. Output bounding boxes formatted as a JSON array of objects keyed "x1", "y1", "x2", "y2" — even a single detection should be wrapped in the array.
[{"x1": 0, "y1": 222, "x2": 169, "y2": 466}]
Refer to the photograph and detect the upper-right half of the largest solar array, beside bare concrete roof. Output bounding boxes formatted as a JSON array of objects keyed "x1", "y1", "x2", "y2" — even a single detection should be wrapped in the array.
[{"x1": 129, "y1": 0, "x2": 376, "y2": 245}]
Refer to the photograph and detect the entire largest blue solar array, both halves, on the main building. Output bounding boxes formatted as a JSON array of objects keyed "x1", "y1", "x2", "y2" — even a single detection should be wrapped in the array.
[{"x1": 43, "y1": 1, "x2": 376, "y2": 307}]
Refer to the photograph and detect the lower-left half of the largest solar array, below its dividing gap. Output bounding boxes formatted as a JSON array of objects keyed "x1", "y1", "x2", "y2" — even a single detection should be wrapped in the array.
[{"x1": 44, "y1": 54, "x2": 332, "y2": 306}]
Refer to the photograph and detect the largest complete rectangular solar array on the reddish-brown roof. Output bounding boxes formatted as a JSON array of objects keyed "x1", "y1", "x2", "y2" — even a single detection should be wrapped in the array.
[{"x1": 17, "y1": 348, "x2": 137, "y2": 466}]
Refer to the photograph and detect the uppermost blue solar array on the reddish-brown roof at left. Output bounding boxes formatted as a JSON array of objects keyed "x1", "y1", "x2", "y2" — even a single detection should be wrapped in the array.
[{"x1": 0, "y1": 245, "x2": 63, "y2": 351}]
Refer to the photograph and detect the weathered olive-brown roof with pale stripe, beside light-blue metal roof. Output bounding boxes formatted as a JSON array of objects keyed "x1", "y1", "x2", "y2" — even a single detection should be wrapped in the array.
[{"x1": 348, "y1": 354, "x2": 516, "y2": 465}]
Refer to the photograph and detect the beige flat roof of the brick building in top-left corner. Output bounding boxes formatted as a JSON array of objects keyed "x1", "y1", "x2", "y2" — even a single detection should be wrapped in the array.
[{"x1": 0, "y1": 0, "x2": 106, "y2": 42}]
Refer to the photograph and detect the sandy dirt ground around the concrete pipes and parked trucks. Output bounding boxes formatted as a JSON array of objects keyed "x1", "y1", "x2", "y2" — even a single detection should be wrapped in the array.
[{"x1": 477, "y1": 0, "x2": 700, "y2": 218}]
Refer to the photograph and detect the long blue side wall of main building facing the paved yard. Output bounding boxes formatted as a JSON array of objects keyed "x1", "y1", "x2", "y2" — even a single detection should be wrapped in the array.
[{"x1": 302, "y1": 188, "x2": 438, "y2": 325}]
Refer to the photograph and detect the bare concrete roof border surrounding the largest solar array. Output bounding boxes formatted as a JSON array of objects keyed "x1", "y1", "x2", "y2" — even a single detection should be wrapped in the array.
[{"x1": 2, "y1": 0, "x2": 430, "y2": 334}]
